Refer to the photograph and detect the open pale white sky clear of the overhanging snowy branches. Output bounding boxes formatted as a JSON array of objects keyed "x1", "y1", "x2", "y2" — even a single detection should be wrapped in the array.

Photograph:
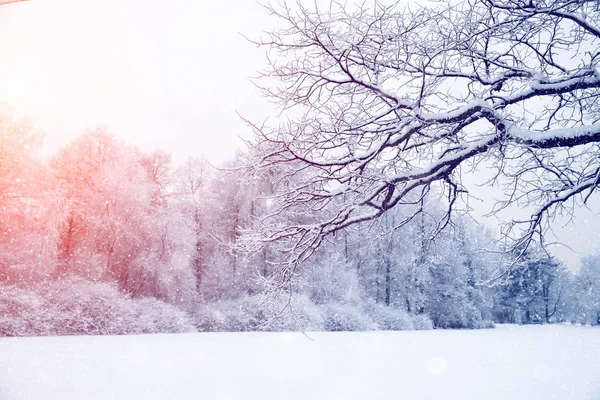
[{"x1": 0, "y1": 0, "x2": 600, "y2": 269}]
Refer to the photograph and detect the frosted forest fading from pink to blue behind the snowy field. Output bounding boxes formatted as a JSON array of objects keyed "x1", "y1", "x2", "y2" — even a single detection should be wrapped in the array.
[{"x1": 0, "y1": 107, "x2": 600, "y2": 336}]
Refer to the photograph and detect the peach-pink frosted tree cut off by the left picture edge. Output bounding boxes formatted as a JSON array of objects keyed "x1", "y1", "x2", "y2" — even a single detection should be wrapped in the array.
[{"x1": 0, "y1": 107, "x2": 62, "y2": 284}]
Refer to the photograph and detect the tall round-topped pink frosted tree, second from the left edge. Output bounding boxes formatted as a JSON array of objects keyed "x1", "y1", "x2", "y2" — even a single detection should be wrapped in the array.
[{"x1": 51, "y1": 130, "x2": 153, "y2": 285}]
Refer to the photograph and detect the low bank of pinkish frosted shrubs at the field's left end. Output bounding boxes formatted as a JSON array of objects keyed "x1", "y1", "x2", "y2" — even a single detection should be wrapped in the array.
[{"x1": 0, "y1": 278, "x2": 195, "y2": 336}]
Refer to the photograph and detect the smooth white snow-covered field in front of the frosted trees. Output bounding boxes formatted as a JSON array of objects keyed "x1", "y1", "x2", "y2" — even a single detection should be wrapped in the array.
[{"x1": 0, "y1": 326, "x2": 600, "y2": 400}]
